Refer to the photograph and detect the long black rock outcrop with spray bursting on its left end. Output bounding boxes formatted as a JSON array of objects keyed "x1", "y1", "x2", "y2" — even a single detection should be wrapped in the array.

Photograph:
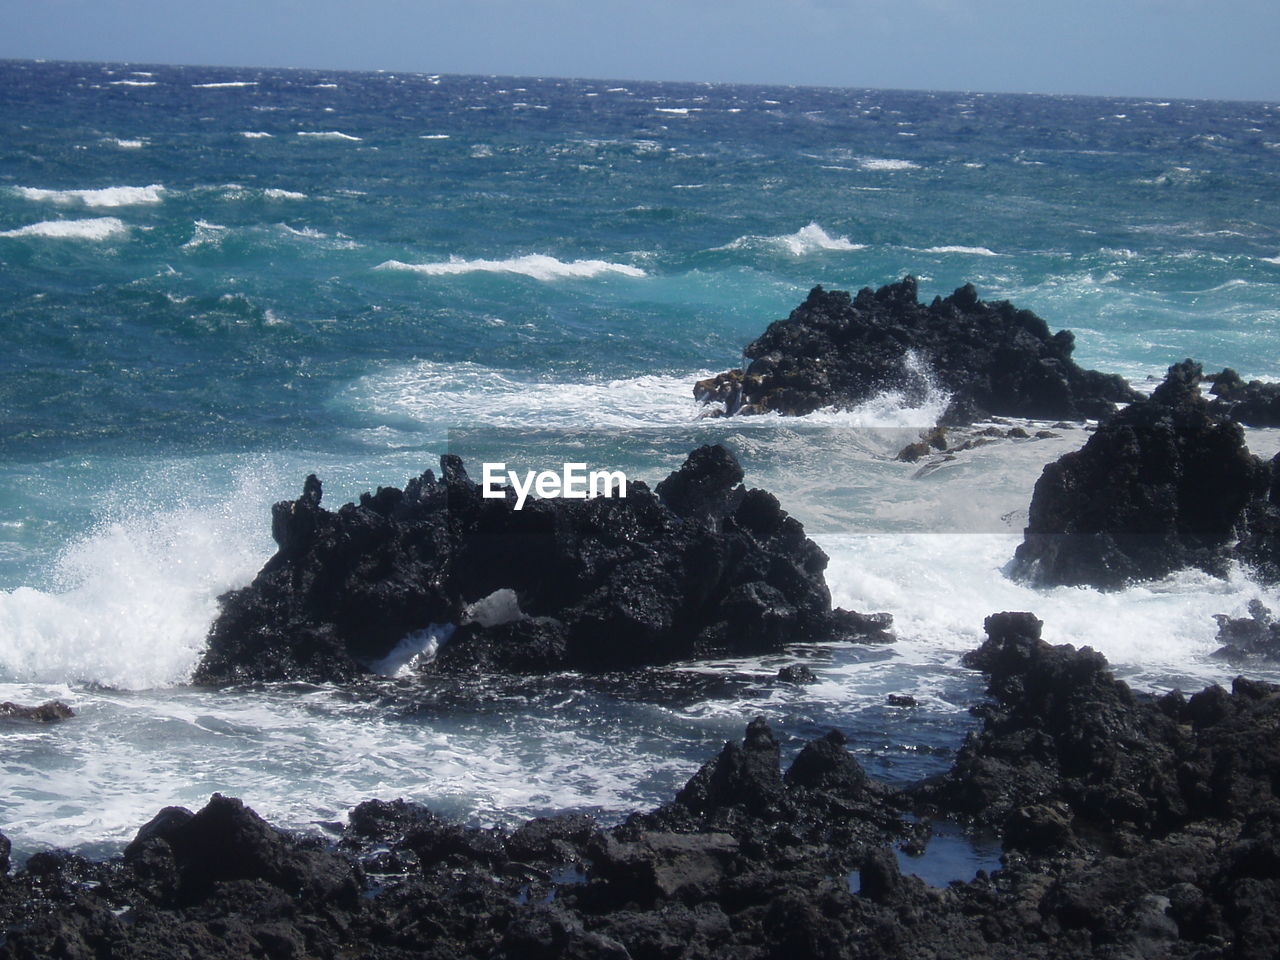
[{"x1": 193, "y1": 447, "x2": 890, "y2": 684}]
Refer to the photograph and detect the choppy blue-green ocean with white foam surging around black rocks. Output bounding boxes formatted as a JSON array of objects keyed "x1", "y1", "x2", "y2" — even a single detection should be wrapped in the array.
[{"x1": 0, "y1": 61, "x2": 1280, "y2": 859}]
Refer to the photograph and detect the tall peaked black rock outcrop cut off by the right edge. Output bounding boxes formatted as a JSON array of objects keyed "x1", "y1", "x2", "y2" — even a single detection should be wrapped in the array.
[{"x1": 1011, "y1": 360, "x2": 1277, "y2": 589}]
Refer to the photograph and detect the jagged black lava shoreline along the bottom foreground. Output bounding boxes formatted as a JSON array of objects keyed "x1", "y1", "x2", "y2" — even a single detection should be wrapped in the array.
[{"x1": 0, "y1": 613, "x2": 1280, "y2": 960}]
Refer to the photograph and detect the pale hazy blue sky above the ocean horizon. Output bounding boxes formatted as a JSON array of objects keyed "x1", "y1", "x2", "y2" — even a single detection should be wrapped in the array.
[{"x1": 0, "y1": 0, "x2": 1280, "y2": 100}]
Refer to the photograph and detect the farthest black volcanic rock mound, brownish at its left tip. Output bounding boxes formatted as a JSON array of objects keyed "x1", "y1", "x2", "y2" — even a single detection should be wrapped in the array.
[{"x1": 694, "y1": 276, "x2": 1137, "y2": 424}]
